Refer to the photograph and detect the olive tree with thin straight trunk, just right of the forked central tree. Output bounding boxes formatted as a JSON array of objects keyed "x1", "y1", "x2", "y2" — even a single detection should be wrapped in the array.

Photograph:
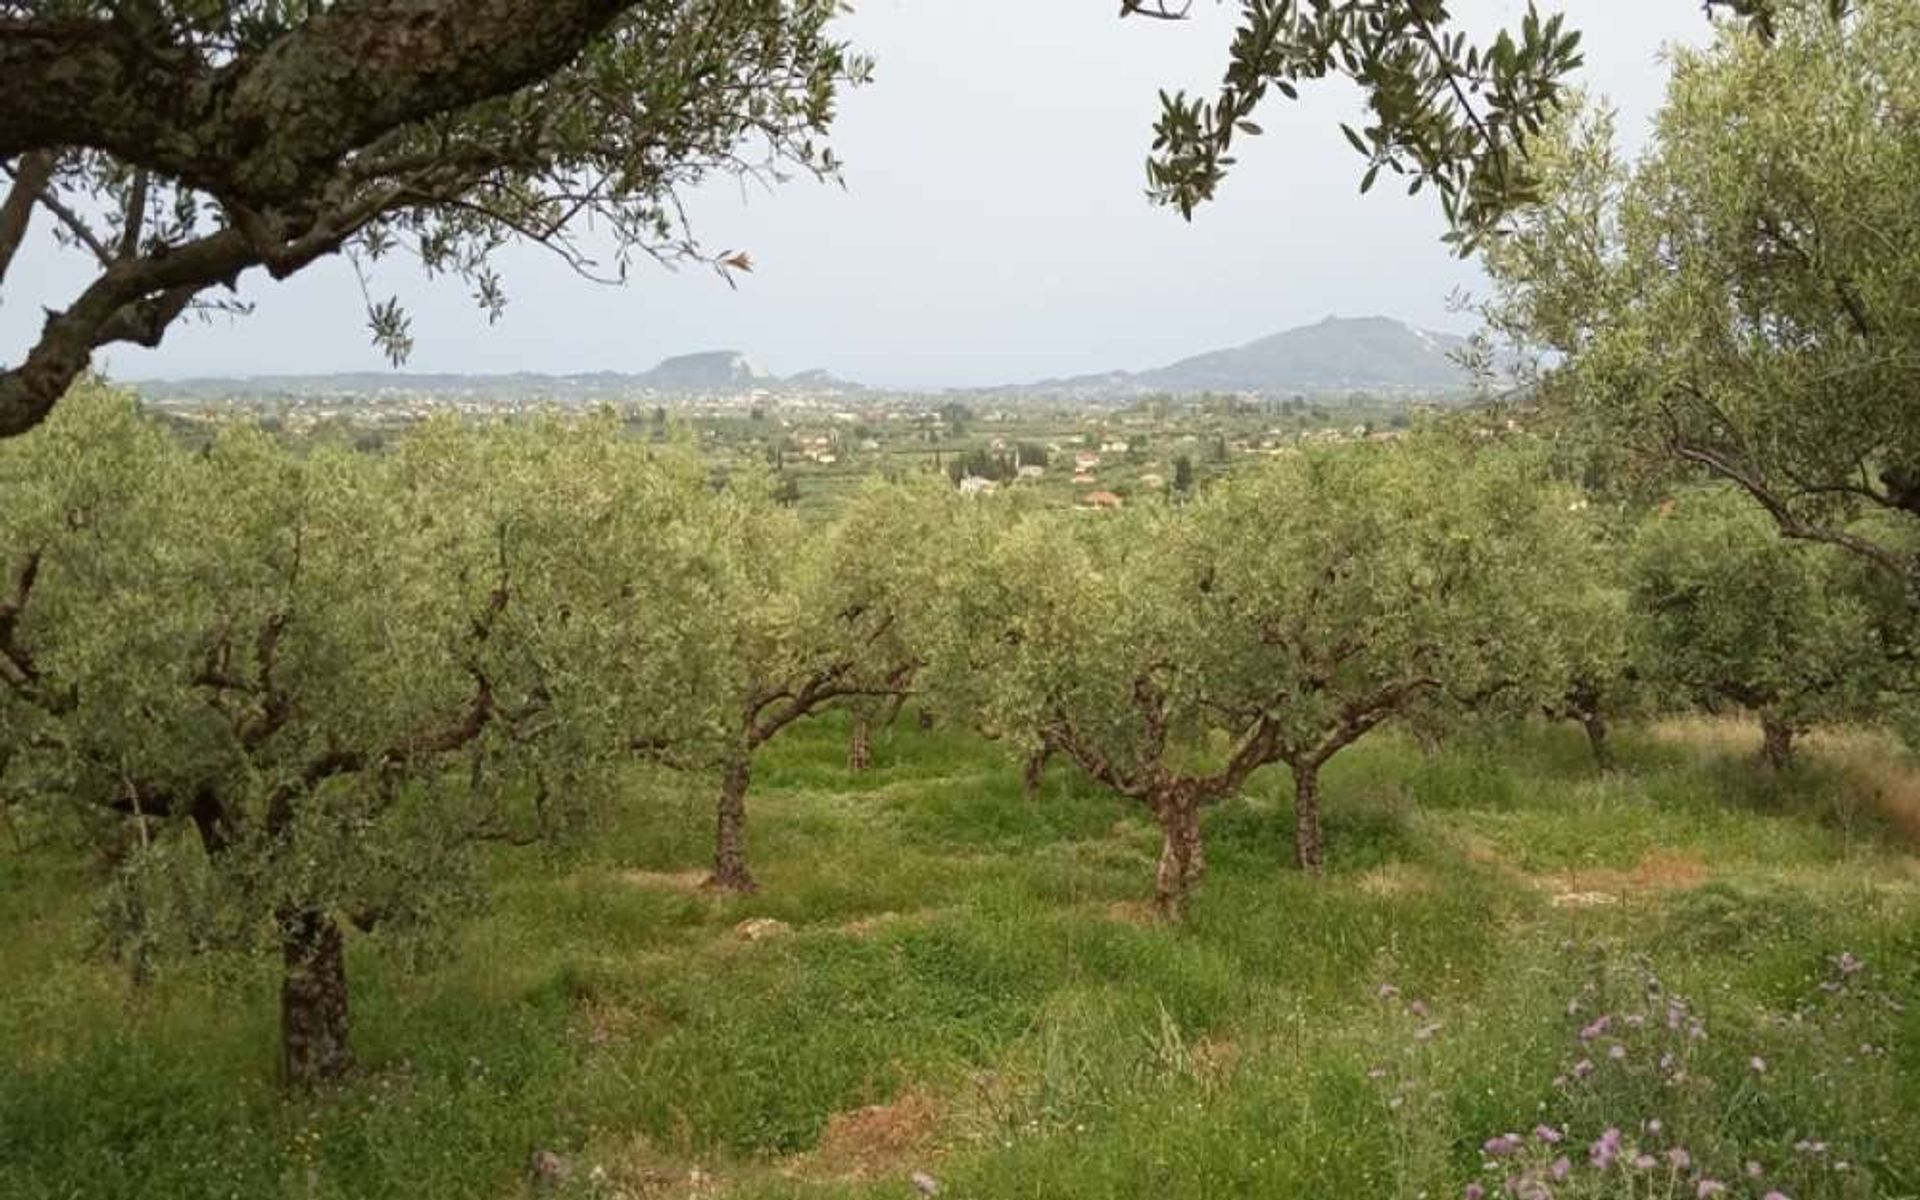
[{"x1": 1187, "y1": 444, "x2": 1594, "y2": 870}]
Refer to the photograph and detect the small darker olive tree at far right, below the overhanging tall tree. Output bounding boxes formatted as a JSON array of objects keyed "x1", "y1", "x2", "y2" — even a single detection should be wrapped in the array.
[{"x1": 1630, "y1": 488, "x2": 1889, "y2": 766}]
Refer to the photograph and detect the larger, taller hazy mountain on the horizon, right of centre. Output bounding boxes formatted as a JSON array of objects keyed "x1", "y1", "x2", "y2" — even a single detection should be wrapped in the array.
[{"x1": 1023, "y1": 317, "x2": 1469, "y2": 394}]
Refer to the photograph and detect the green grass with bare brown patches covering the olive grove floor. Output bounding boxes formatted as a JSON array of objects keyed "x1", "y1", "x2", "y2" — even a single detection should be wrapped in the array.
[{"x1": 0, "y1": 720, "x2": 1920, "y2": 1200}]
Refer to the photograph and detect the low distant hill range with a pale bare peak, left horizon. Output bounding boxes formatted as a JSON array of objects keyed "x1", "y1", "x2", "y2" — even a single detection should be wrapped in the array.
[{"x1": 136, "y1": 349, "x2": 864, "y2": 403}]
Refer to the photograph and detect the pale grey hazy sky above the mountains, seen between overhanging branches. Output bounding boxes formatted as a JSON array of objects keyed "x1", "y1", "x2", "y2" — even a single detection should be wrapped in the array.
[{"x1": 0, "y1": 0, "x2": 1707, "y2": 386}]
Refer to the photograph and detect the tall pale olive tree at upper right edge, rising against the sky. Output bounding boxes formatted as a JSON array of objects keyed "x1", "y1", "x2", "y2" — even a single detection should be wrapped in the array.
[{"x1": 1486, "y1": 0, "x2": 1920, "y2": 611}]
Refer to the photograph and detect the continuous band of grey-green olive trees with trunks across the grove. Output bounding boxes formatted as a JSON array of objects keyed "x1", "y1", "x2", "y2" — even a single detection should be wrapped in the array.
[{"x1": 0, "y1": 386, "x2": 1912, "y2": 1085}]
